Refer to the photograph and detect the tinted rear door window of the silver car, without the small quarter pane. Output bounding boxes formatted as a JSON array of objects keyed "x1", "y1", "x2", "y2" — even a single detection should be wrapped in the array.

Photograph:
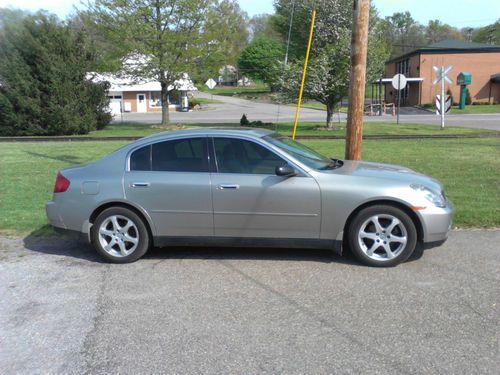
[{"x1": 151, "y1": 138, "x2": 208, "y2": 172}]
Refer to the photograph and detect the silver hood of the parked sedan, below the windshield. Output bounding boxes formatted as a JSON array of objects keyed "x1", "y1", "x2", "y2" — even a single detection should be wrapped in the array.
[{"x1": 328, "y1": 160, "x2": 442, "y2": 192}]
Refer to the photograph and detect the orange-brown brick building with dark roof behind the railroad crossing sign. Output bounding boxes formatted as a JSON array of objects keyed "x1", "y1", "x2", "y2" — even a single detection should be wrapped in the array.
[{"x1": 384, "y1": 40, "x2": 500, "y2": 105}]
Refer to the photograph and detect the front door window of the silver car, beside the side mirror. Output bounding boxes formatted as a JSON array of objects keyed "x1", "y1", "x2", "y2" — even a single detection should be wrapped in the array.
[{"x1": 214, "y1": 138, "x2": 285, "y2": 174}]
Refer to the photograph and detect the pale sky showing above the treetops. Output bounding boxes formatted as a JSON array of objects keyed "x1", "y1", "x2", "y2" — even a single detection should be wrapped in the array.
[{"x1": 0, "y1": 0, "x2": 500, "y2": 28}]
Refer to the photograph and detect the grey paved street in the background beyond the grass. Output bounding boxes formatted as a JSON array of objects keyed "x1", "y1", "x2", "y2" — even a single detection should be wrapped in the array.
[{"x1": 117, "y1": 92, "x2": 500, "y2": 130}]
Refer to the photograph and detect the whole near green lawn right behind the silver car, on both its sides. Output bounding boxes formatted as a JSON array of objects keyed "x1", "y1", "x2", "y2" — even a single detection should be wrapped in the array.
[{"x1": 0, "y1": 138, "x2": 500, "y2": 235}]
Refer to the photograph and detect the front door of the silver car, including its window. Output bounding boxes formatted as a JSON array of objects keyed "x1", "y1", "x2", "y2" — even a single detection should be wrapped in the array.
[{"x1": 211, "y1": 137, "x2": 321, "y2": 238}]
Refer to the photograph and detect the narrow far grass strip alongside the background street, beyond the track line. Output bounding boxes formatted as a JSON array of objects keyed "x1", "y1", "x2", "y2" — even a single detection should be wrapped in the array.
[{"x1": 89, "y1": 119, "x2": 500, "y2": 137}]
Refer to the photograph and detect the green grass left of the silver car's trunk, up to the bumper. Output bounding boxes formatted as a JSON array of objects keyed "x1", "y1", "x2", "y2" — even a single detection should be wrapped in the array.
[{"x1": 0, "y1": 142, "x2": 127, "y2": 234}]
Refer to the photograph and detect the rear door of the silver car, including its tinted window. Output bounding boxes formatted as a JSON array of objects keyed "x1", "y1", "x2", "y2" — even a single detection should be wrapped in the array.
[{"x1": 124, "y1": 137, "x2": 213, "y2": 236}]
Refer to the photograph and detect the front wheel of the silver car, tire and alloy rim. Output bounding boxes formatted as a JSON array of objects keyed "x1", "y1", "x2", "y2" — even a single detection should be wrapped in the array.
[{"x1": 348, "y1": 205, "x2": 417, "y2": 267}]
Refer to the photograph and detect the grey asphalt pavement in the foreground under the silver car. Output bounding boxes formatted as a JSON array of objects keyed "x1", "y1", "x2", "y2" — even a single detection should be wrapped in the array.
[{"x1": 0, "y1": 231, "x2": 500, "y2": 374}]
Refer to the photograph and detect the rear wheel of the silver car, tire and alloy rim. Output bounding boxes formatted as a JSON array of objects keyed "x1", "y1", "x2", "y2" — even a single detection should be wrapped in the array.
[{"x1": 91, "y1": 207, "x2": 151, "y2": 263}]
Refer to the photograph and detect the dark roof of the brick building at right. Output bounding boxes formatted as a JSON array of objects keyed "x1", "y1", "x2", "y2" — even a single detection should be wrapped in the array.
[{"x1": 386, "y1": 39, "x2": 500, "y2": 64}]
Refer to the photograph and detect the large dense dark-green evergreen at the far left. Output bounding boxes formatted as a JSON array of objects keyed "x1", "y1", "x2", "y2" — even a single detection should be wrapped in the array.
[{"x1": 0, "y1": 9, "x2": 111, "y2": 136}]
